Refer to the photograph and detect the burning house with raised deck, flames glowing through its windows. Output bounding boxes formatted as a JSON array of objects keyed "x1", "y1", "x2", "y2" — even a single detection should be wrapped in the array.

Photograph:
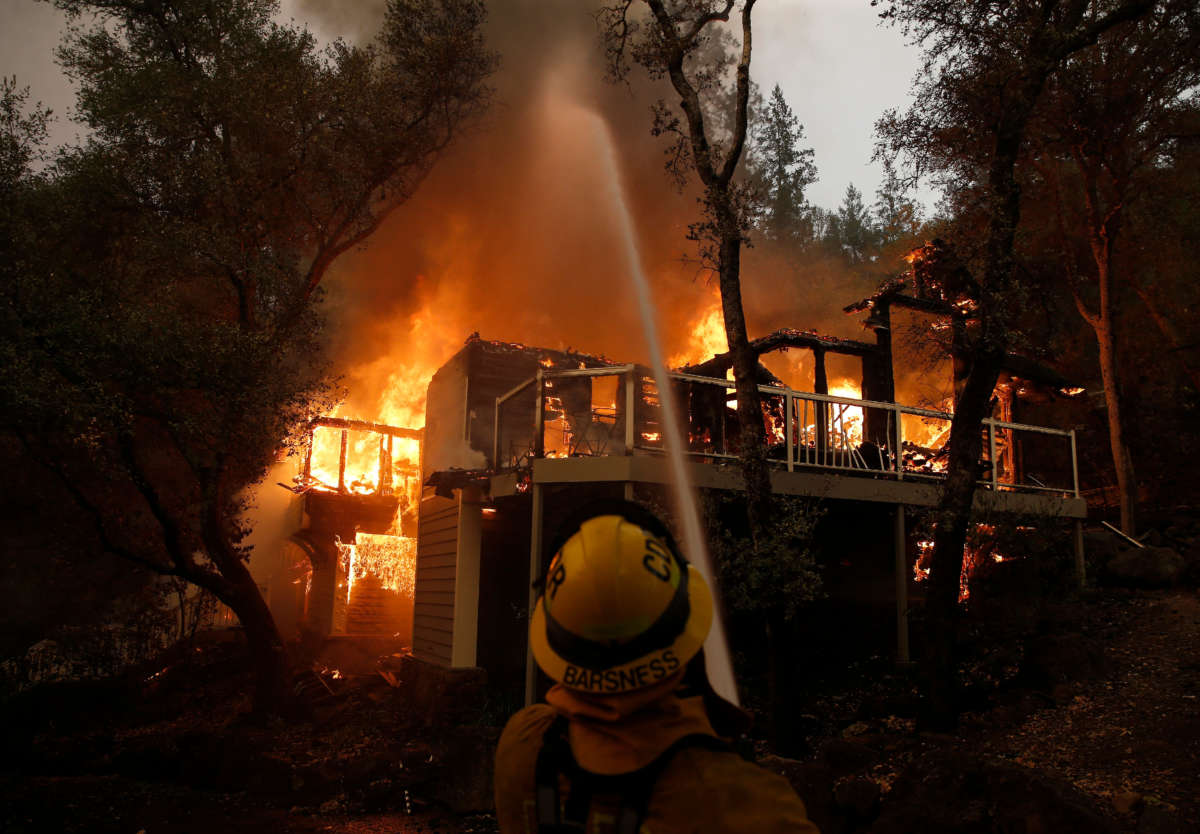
[{"x1": 265, "y1": 288, "x2": 1086, "y2": 705}]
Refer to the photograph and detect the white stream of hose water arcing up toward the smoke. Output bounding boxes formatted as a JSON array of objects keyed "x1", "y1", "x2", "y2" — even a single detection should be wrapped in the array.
[{"x1": 589, "y1": 114, "x2": 739, "y2": 703}]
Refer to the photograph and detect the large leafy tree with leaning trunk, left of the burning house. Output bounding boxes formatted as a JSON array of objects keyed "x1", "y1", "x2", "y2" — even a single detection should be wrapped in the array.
[{"x1": 0, "y1": 0, "x2": 496, "y2": 710}]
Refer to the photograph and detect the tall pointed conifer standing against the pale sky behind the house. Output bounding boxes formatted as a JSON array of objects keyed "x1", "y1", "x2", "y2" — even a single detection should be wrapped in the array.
[{"x1": 746, "y1": 84, "x2": 817, "y2": 246}]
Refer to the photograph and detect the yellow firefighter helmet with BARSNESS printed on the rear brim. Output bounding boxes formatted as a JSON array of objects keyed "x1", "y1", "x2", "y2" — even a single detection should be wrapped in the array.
[{"x1": 529, "y1": 502, "x2": 713, "y2": 695}]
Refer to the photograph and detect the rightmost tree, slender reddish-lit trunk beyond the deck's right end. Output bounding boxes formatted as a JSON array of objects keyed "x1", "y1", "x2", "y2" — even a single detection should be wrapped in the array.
[{"x1": 1030, "y1": 7, "x2": 1200, "y2": 534}]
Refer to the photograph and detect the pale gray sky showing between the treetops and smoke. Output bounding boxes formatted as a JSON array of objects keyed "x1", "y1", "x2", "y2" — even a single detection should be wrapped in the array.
[{"x1": 0, "y1": 0, "x2": 917, "y2": 208}]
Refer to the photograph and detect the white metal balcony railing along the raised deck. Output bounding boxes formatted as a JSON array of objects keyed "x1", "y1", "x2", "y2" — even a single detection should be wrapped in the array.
[{"x1": 492, "y1": 365, "x2": 1079, "y2": 497}]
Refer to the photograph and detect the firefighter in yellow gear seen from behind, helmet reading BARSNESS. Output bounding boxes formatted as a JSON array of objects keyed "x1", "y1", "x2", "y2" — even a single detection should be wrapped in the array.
[{"x1": 496, "y1": 502, "x2": 817, "y2": 834}]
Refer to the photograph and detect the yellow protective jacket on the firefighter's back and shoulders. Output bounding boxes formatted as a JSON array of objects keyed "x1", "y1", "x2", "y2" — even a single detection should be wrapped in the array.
[{"x1": 496, "y1": 686, "x2": 818, "y2": 834}]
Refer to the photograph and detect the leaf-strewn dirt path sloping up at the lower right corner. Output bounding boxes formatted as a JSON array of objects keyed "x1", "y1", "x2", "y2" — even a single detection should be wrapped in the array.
[{"x1": 988, "y1": 590, "x2": 1200, "y2": 830}]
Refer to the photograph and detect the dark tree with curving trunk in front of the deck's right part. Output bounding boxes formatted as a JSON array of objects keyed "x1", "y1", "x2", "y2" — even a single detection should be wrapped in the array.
[{"x1": 872, "y1": 0, "x2": 1159, "y2": 725}]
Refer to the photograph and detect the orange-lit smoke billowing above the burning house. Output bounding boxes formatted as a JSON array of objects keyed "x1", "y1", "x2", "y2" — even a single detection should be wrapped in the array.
[{"x1": 285, "y1": 0, "x2": 897, "y2": 425}]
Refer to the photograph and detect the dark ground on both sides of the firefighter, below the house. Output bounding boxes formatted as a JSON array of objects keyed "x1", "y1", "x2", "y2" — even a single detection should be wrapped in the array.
[{"x1": 0, "y1": 588, "x2": 1200, "y2": 834}]
